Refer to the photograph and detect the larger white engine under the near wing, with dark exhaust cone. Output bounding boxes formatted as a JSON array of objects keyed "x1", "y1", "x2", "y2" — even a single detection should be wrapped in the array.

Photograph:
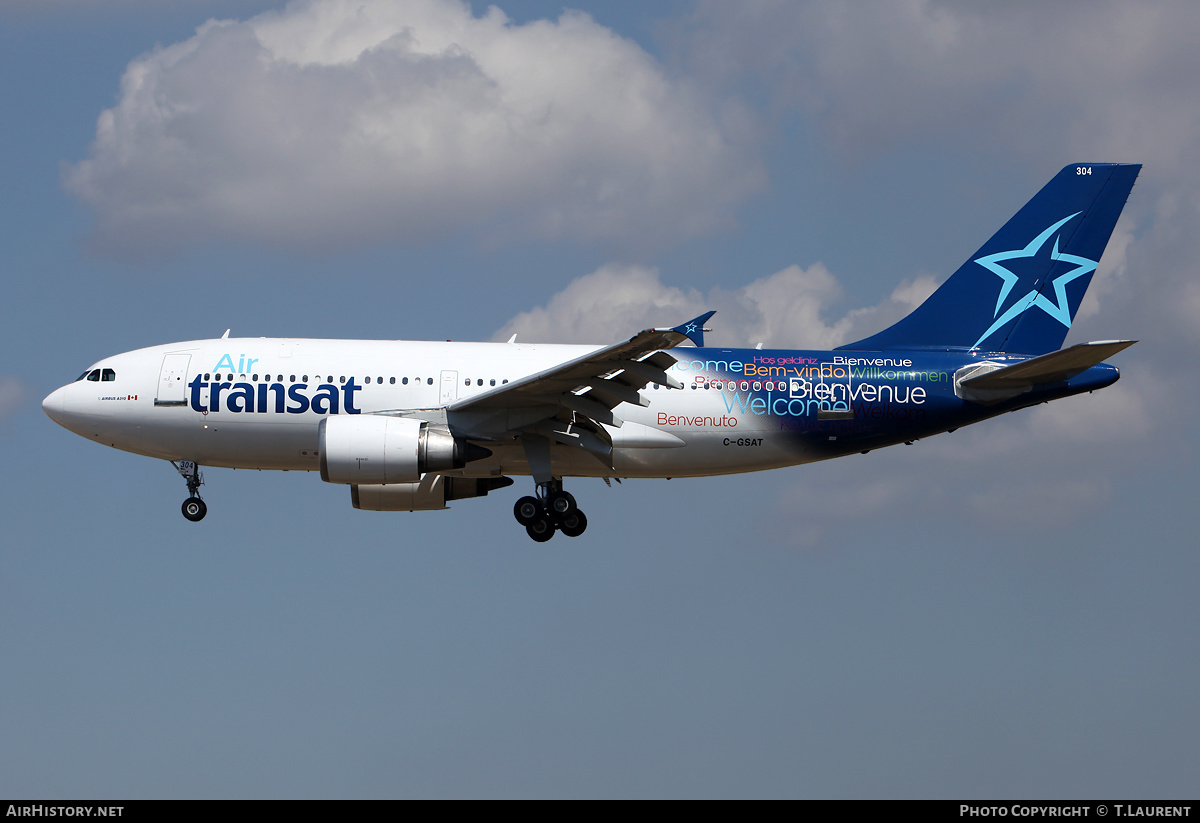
[{"x1": 318, "y1": 414, "x2": 492, "y2": 485}]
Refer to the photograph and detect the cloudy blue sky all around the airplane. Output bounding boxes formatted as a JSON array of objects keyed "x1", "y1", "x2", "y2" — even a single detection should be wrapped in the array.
[{"x1": 0, "y1": 0, "x2": 1200, "y2": 798}]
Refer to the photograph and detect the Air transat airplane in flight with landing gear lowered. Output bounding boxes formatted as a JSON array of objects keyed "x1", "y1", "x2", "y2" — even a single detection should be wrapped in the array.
[{"x1": 42, "y1": 163, "x2": 1141, "y2": 542}]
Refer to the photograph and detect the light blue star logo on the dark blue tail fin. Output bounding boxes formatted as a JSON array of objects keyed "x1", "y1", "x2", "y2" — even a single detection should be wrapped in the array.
[{"x1": 971, "y1": 211, "x2": 1097, "y2": 349}]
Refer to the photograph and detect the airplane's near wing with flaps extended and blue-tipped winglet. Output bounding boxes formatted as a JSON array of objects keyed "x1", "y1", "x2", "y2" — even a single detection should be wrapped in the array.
[{"x1": 446, "y1": 312, "x2": 715, "y2": 479}]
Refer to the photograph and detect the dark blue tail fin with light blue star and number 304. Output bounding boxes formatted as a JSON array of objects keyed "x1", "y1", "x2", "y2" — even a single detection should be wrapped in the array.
[{"x1": 840, "y1": 163, "x2": 1141, "y2": 354}]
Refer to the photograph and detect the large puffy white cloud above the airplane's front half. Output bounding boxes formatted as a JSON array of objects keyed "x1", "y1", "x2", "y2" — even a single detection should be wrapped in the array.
[{"x1": 65, "y1": 0, "x2": 763, "y2": 253}]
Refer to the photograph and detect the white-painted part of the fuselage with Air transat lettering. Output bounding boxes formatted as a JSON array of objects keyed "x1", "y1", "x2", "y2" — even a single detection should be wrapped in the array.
[{"x1": 43, "y1": 338, "x2": 827, "y2": 477}]
